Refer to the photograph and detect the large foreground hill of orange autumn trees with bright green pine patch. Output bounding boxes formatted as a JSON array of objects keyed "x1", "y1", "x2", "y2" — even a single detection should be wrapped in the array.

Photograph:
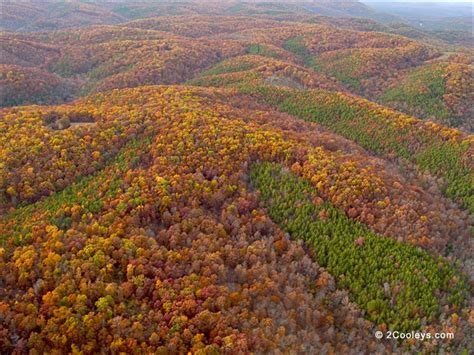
[{"x1": 0, "y1": 87, "x2": 469, "y2": 352}]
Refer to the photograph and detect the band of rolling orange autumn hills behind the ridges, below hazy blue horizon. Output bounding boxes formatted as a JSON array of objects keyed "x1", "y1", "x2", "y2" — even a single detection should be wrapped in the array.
[{"x1": 0, "y1": 15, "x2": 473, "y2": 132}]
